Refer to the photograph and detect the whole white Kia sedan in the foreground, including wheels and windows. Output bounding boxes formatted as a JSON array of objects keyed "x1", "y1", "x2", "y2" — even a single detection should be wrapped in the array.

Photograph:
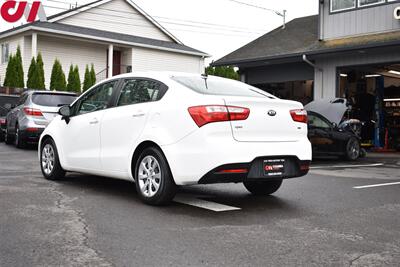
[{"x1": 39, "y1": 72, "x2": 311, "y2": 205}]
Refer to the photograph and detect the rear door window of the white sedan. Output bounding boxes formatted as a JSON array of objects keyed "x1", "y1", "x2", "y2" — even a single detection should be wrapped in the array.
[{"x1": 118, "y1": 79, "x2": 162, "y2": 106}]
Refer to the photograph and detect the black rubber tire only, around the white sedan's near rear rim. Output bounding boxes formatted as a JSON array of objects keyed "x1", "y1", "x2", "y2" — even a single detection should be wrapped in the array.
[{"x1": 134, "y1": 147, "x2": 176, "y2": 206}]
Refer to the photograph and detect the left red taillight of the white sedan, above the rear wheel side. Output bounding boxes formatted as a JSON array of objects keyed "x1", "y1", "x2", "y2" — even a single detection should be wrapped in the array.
[{"x1": 188, "y1": 105, "x2": 250, "y2": 127}]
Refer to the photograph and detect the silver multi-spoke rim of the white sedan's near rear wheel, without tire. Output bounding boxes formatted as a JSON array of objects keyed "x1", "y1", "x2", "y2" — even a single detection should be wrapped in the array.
[{"x1": 138, "y1": 156, "x2": 161, "y2": 197}]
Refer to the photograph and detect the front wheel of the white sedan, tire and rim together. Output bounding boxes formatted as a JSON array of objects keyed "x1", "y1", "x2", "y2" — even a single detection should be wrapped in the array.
[{"x1": 40, "y1": 138, "x2": 65, "y2": 181}]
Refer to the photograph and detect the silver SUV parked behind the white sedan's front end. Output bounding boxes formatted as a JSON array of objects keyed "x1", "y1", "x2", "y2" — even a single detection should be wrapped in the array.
[{"x1": 4, "y1": 91, "x2": 77, "y2": 148}]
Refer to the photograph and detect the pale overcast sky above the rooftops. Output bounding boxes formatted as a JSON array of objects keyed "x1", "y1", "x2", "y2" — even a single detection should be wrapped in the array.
[{"x1": 0, "y1": 0, "x2": 319, "y2": 63}]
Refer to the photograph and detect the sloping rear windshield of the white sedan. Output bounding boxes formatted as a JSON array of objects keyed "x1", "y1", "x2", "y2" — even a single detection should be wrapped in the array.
[{"x1": 172, "y1": 76, "x2": 276, "y2": 98}]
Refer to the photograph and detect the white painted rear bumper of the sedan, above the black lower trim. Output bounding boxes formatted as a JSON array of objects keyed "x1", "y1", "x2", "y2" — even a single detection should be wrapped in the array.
[{"x1": 161, "y1": 123, "x2": 312, "y2": 185}]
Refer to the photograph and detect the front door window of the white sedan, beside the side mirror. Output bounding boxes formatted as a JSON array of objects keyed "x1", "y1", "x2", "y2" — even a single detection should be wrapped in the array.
[{"x1": 76, "y1": 81, "x2": 117, "y2": 115}]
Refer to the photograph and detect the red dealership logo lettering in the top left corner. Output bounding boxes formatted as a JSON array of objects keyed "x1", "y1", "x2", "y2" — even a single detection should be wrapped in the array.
[{"x1": 0, "y1": 0, "x2": 47, "y2": 23}]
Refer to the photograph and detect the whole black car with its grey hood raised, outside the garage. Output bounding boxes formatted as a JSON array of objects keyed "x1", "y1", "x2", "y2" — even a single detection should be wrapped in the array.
[{"x1": 305, "y1": 98, "x2": 364, "y2": 161}]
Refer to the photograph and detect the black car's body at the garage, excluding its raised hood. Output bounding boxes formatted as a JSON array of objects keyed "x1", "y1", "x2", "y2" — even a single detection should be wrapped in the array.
[{"x1": 308, "y1": 111, "x2": 361, "y2": 160}]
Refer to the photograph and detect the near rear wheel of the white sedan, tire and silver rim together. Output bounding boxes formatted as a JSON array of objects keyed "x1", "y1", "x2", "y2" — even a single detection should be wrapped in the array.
[{"x1": 134, "y1": 147, "x2": 177, "y2": 206}]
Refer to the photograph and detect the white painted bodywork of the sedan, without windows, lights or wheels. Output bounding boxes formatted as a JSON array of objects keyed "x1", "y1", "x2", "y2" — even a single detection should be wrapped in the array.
[{"x1": 39, "y1": 72, "x2": 311, "y2": 204}]
